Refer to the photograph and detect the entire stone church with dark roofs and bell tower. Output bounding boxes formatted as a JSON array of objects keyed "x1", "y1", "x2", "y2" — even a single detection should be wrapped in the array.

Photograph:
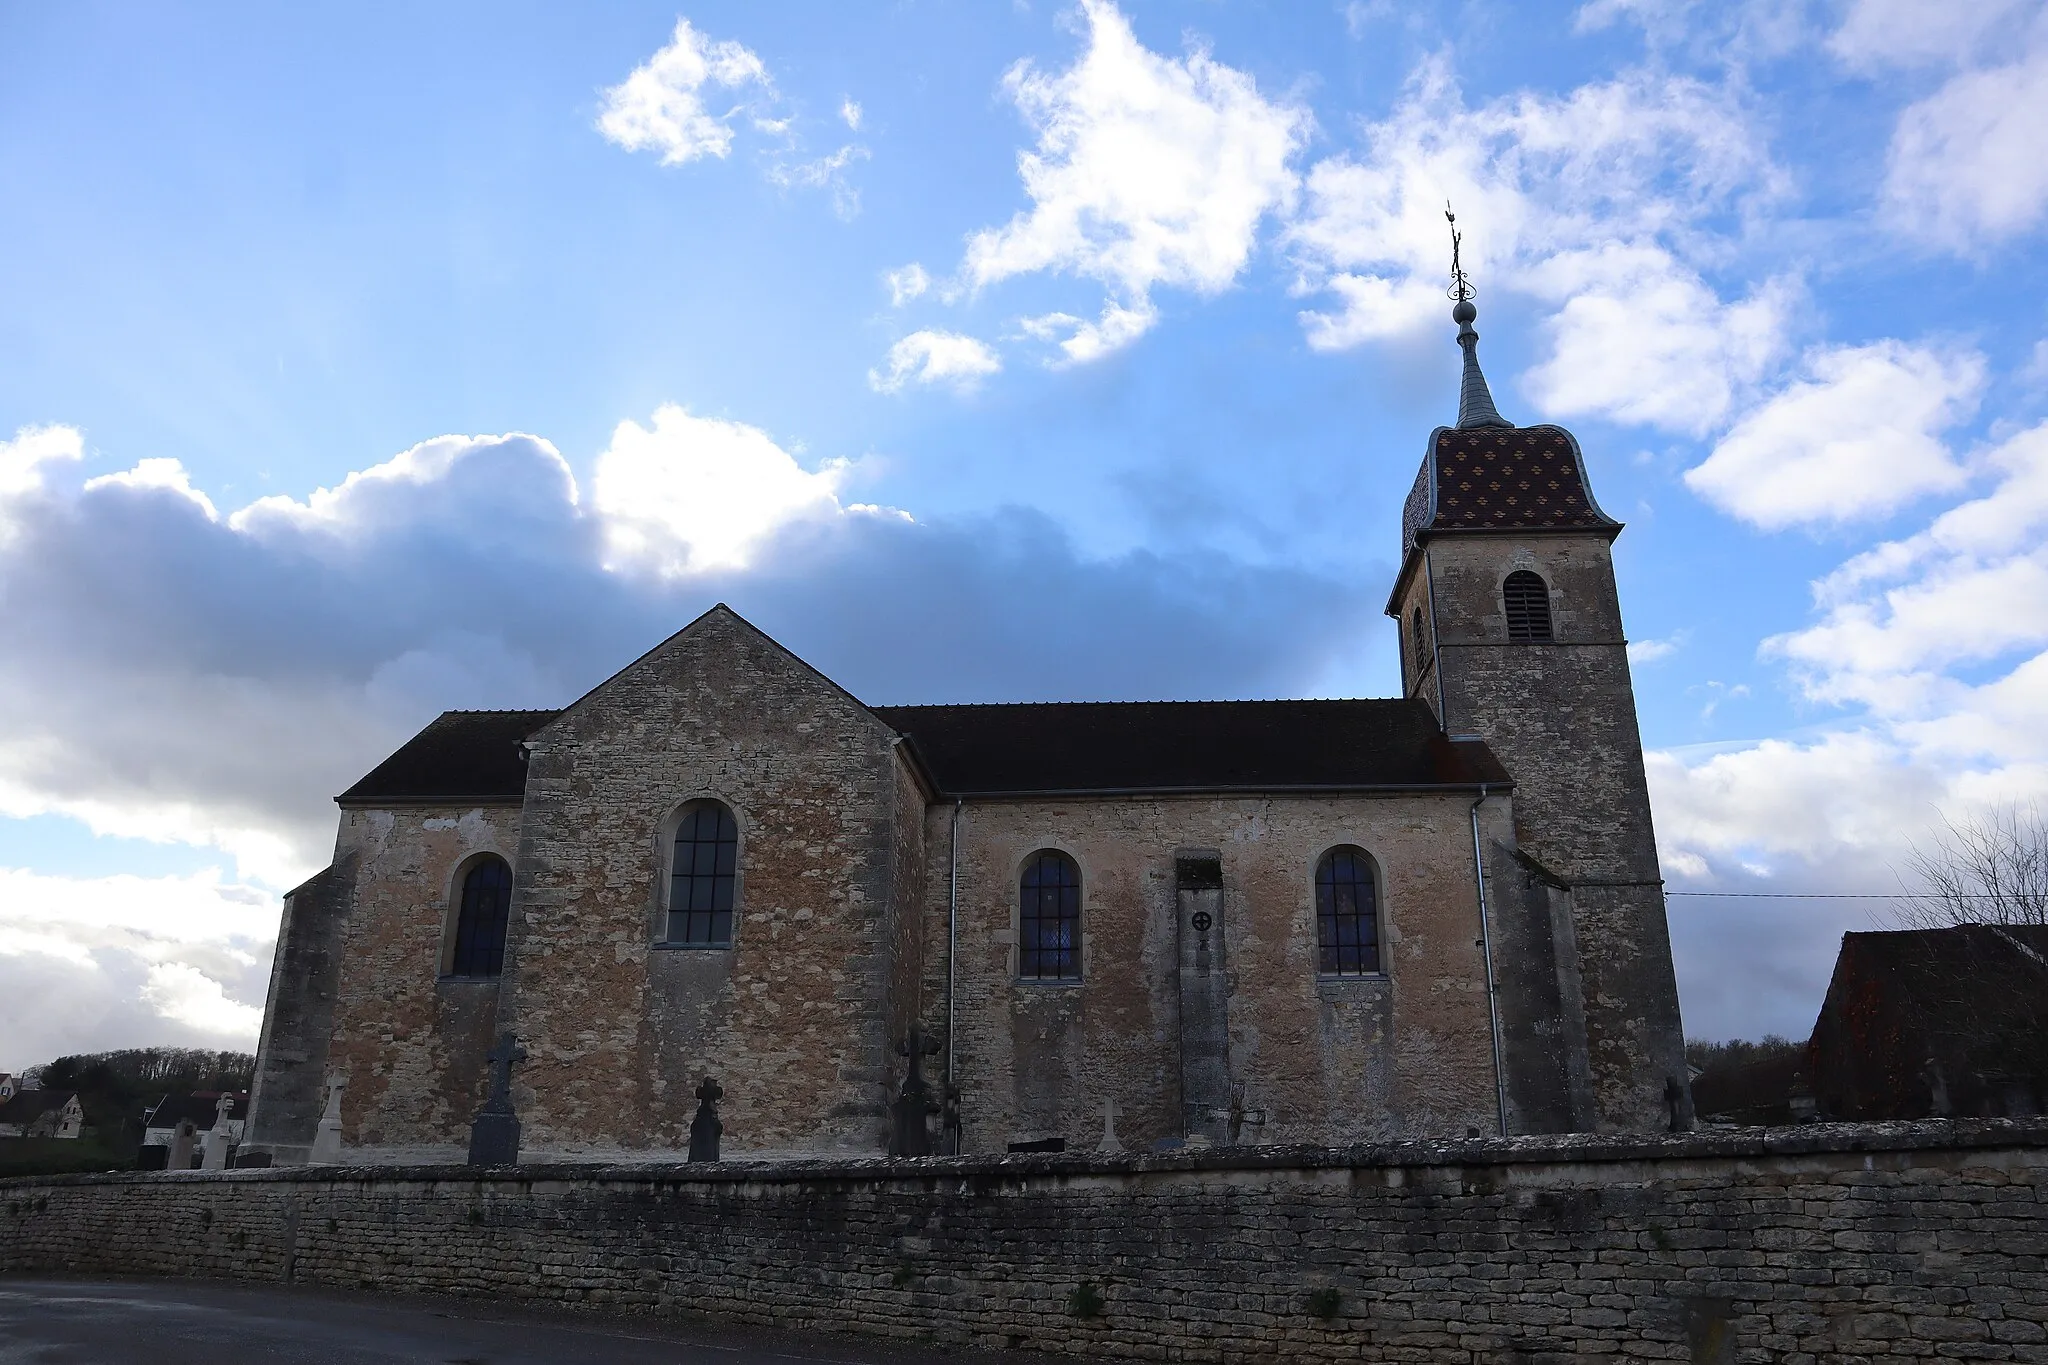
[{"x1": 248, "y1": 303, "x2": 1690, "y2": 1164}]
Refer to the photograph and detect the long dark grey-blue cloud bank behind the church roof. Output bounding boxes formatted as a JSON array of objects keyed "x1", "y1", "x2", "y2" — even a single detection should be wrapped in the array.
[{"x1": 0, "y1": 436, "x2": 1380, "y2": 874}]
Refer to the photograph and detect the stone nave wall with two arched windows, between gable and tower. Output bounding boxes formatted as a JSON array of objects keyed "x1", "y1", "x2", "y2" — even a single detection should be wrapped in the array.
[{"x1": 926, "y1": 794, "x2": 1530, "y2": 1152}]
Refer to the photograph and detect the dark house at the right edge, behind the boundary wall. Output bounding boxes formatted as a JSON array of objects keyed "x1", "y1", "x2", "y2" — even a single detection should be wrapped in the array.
[{"x1": 1808, "y1": 925, "x2": 2048, "y2": 1119}]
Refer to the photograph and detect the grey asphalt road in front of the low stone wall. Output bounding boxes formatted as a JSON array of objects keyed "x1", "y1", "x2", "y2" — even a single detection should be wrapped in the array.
[{"x1": 0, "y1": 1277, "x2": 1071, "y2": 1365}]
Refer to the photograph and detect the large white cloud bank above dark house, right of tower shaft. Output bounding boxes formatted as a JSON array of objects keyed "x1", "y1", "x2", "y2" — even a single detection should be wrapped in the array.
[{"x1": 1649, "y1": 424, "x2": 2048, "y2": 1031}]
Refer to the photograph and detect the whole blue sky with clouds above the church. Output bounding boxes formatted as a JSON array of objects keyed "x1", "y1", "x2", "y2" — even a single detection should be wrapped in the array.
[{"x1": 0, "y1": 0, "x2": 2048, "y2": 1068}]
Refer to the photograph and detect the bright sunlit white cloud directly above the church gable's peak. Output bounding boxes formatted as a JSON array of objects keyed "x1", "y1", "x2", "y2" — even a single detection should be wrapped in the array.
[{"x1": 592, "y1": 403, "x2": 848, "y2": 575}]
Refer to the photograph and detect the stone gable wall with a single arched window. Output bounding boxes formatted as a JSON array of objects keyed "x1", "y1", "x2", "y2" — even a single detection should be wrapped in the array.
[{"x1": 495, "y1": 608, "x2": 905, "y2": 1158}]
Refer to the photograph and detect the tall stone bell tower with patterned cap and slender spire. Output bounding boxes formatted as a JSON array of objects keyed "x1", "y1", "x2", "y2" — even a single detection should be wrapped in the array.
[{"x1": 1386, "y1": 213, "x2": 1692, "y2": 1132}]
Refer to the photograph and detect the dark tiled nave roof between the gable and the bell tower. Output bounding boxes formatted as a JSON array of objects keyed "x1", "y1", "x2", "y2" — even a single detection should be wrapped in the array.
[{"x1": 874, "y1": 700, "x2": 1509, "y2": 796}]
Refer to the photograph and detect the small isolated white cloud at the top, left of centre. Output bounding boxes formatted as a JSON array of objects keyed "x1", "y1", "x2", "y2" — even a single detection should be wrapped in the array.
[{"x1": 598, "y1": 18, "x2": 772, "y2": 166}]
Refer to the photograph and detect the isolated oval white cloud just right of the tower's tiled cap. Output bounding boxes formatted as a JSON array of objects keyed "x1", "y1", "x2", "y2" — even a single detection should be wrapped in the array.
[{"x1": 1686, "y1": 340, "x2": 1985, "y2": 530}]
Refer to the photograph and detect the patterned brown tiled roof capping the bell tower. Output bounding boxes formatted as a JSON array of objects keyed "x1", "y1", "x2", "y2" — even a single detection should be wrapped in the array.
[{"x1": 1401, "y1": 426, "x2": 1620, "y2": 555}]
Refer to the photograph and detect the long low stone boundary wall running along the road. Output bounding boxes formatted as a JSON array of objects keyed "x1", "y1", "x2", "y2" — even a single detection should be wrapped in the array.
[{"x1": 0, "y1": 1119, "x2": 2048, "y2": 1365}]
